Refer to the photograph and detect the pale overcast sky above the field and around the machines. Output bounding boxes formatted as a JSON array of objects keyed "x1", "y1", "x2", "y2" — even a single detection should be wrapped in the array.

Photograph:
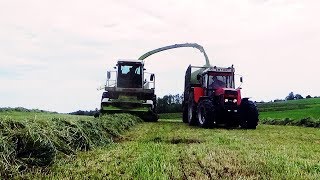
[{"x1": 0, "y1": 0, "x2": 320, "y2": 112}]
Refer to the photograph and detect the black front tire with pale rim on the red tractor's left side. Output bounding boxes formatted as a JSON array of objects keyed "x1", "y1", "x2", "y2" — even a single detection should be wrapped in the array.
[{"x1": 197, "y1": 99, "x2": 216, "y2": 128}]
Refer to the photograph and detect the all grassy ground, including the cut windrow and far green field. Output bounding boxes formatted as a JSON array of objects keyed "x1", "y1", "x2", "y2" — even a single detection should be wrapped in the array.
[{"x1": 0, "y1": 99, "x2": 320, "y2": 179}]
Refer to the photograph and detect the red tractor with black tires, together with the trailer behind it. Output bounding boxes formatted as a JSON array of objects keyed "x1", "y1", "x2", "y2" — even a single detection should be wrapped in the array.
[{"x1": 183, "y1": 65, "x2": 259, "y2": 129}]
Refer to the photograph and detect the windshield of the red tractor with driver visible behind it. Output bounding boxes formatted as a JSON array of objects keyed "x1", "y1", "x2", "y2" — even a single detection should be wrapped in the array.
[{"x1": 208, "y1": 73, "x2": 235, "y2": 89}]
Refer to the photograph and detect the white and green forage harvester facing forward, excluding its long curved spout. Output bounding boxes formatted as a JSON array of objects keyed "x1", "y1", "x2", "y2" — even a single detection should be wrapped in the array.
[{"x1": 100, "y1": 60, "x2": 158, "y2": 121}]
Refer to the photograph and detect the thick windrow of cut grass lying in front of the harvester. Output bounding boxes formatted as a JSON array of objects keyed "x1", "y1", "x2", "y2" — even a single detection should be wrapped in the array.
[{"x1": 0, "y1": 114, "x2": 141, "y2": 179}]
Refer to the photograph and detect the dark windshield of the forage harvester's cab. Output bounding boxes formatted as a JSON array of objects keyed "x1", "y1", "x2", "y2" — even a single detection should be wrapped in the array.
[{"x1": 117, "y1": 63, "x2": 142, "y2": 88}]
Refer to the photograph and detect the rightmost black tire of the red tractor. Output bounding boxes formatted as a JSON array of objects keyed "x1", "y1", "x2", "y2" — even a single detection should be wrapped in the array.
[{"x1": 240, "y1": 99, "x2": 259, "y2": 129}]
